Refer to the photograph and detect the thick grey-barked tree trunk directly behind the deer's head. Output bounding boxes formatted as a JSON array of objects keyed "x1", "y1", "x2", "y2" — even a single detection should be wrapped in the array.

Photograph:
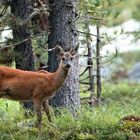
[{"x1": 48, "y1": 0, "x2": 80, "y2": 113}]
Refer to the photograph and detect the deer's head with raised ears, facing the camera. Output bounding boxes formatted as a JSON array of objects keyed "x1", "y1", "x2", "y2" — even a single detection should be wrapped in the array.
[{"x1": 57, "y1": 45, "x2": 79, "y2": 70}]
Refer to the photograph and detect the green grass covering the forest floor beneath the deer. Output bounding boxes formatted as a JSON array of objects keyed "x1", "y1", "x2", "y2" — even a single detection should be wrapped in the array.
[{"x1": 0, "y1": 83, "x2": 140, "y2": 140}]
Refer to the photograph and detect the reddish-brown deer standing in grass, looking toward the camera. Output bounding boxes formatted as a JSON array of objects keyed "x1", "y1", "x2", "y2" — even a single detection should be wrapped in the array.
[{"x1": 0, "y1": 45, "x2": 78, "y2": 130}]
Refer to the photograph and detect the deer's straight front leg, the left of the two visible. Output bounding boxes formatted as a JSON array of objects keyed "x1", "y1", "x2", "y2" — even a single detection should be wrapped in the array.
[{"x1": 34, "y1": 98, "x2": 42, "y2": 130}]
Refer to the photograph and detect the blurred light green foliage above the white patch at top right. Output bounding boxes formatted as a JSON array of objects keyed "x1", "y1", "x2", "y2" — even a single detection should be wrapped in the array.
[{"x1": 78, "y1": 0, "x2": 140, "y2": 26}]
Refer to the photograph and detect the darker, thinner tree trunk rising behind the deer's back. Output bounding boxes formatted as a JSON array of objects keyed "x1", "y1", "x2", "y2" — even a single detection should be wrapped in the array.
[{"x1": 11, "y1": 0, "x2": 34, "y2": 109}]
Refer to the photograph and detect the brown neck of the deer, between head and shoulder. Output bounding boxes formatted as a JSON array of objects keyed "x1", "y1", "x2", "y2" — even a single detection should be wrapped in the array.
[{"x1": 53, "y1": 62, "x2": 69, "y2": 90}]
